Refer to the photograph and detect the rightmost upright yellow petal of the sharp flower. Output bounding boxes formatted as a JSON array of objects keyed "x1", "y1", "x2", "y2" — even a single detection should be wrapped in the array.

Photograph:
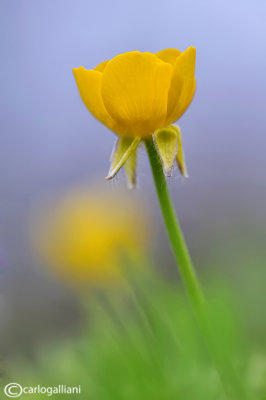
[{"x1": 166, "y1": 47, "x2": 196, "y2": 125}]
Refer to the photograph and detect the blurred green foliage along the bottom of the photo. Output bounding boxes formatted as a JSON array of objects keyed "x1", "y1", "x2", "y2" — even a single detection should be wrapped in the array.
[{"x1": 2, "y1": 276, "x2": 266, "y2": 400}]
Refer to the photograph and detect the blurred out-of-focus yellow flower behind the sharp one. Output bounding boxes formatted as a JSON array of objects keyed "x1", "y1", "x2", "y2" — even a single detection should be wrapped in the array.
[{"x1": 33, "y1": 189, "x2": 150, "y2": 285}]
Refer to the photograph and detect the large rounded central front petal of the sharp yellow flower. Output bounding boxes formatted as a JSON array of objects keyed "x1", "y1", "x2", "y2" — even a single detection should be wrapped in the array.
[{"x1": 102, "y1": 51, "x2": 172, "y2": 137}]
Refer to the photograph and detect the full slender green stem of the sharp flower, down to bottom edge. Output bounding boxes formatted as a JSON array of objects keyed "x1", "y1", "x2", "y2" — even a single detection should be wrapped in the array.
[{"x1": 145, "y1": 139, "x2": 246, "y2": 400}]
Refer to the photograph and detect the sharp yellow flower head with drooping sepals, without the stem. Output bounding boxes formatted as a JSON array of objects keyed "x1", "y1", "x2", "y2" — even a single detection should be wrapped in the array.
[{"x1": 73, "y1": 47, "x2": 196, "y2": 186}]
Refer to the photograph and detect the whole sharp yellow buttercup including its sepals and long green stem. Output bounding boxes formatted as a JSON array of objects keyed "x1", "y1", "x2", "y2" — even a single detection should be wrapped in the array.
[{"x1": 73, "y1": 47, "x2": 224, "y2": 390}]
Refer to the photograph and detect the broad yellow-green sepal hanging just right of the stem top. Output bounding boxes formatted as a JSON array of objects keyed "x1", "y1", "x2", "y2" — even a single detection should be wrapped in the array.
[{"x1": 154, "y1": 127, "x2": 178, "y2": 176}]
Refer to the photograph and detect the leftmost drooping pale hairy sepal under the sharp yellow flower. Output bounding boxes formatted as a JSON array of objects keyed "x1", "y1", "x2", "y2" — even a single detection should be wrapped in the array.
[{"x1": 105, "y1": 137, "x2": 141, "y2": 180}]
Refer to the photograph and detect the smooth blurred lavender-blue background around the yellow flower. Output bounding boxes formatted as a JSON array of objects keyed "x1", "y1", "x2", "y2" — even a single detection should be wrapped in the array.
[{"x1": 0, "y1": 0, "x2": 266, "y2": 362}]
